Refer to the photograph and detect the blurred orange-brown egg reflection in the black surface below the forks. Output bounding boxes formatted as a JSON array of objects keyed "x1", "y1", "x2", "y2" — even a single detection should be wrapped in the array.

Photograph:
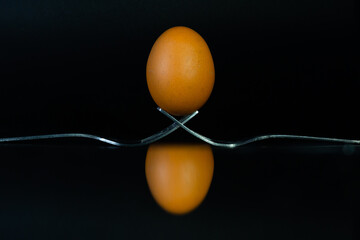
[{"x1": 145, "y1": 144, "x2": 214, "y2": 214}]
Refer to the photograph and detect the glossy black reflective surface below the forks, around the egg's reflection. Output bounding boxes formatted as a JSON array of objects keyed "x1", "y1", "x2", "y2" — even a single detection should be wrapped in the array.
[{"x1": 0, "y1": 143, "x2": 360, "y2": 240}]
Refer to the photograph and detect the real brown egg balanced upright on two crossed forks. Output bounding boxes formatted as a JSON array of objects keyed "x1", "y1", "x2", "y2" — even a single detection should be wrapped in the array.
[{"x1": 146, "y1": 27, "x2": 215, "y2": 116}]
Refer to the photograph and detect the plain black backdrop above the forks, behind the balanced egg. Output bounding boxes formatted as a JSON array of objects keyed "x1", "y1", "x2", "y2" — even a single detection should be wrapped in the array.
[{"x1": 0, "y1": 0, "x2": 360, "y2": 140}]
